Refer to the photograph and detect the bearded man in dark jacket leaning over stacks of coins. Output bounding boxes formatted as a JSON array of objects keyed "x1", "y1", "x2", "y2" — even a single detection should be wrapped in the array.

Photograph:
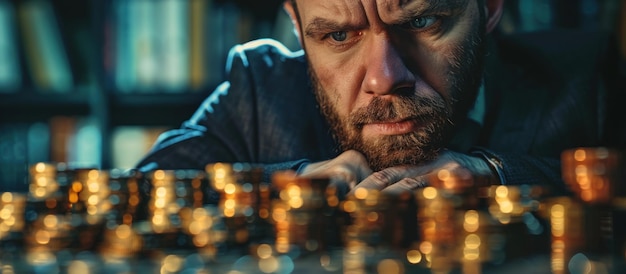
[{"x1": 138, "y1": 0, "x2": 624, "y2": 197}]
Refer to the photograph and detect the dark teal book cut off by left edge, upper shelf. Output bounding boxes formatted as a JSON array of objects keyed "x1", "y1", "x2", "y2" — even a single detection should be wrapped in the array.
[{"x1": 0, "y1": 0, "x2": 22, "y2": 93}]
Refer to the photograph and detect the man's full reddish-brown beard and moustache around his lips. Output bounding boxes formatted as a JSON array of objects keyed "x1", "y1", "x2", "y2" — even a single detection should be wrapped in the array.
[{"x1": 309, "y1": 24, "x2": 485, "y2": 171}]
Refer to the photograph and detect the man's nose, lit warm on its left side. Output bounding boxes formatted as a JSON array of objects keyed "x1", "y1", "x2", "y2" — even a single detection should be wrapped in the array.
[{"x1": 362, "y1": 35, "x2": 415, "y2": 95}]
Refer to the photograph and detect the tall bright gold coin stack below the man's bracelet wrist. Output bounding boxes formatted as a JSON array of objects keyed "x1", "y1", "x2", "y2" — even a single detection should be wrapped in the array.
[{"x1": 414, "y1": 169, "x2": 493, "y2": 273}]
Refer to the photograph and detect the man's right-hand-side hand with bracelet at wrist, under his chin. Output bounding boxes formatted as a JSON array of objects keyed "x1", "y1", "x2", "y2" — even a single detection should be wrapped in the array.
[{"x1": 351, "y1": 150, "x2": 497, "y2": 194}]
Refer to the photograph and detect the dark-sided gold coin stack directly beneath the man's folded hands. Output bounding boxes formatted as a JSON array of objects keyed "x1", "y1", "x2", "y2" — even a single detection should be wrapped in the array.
[{"x1": 340, "y1": 188, "x2": 418, "y2": 273}]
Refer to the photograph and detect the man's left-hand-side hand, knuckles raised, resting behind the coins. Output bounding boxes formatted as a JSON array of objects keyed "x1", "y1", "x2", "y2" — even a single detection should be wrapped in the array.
[{"x1": 300, "y1": 150, "x2": 372, "y2": 189}]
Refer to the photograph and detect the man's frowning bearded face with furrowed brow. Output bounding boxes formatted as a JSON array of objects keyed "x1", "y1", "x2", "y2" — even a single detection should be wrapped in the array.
[{"x1": 297, "y1": 0, "x2": 485, "y2": 170}]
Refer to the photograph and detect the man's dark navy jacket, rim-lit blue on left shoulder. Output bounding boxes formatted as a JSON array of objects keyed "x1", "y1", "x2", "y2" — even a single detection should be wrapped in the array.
[{"x1": 138, "y1": 32, "x2": 626, "y2": 194}]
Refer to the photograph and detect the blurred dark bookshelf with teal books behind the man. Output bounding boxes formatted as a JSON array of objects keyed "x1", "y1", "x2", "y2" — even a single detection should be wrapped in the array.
[{"x1": 0, "y1": 0, "x2": 626, "y2": 190}]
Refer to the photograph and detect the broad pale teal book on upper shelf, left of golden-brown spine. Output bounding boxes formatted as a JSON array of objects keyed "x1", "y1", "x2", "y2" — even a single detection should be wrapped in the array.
[{"x1": 112, "y1": 0, "x2": 190, "y2": 93}]
